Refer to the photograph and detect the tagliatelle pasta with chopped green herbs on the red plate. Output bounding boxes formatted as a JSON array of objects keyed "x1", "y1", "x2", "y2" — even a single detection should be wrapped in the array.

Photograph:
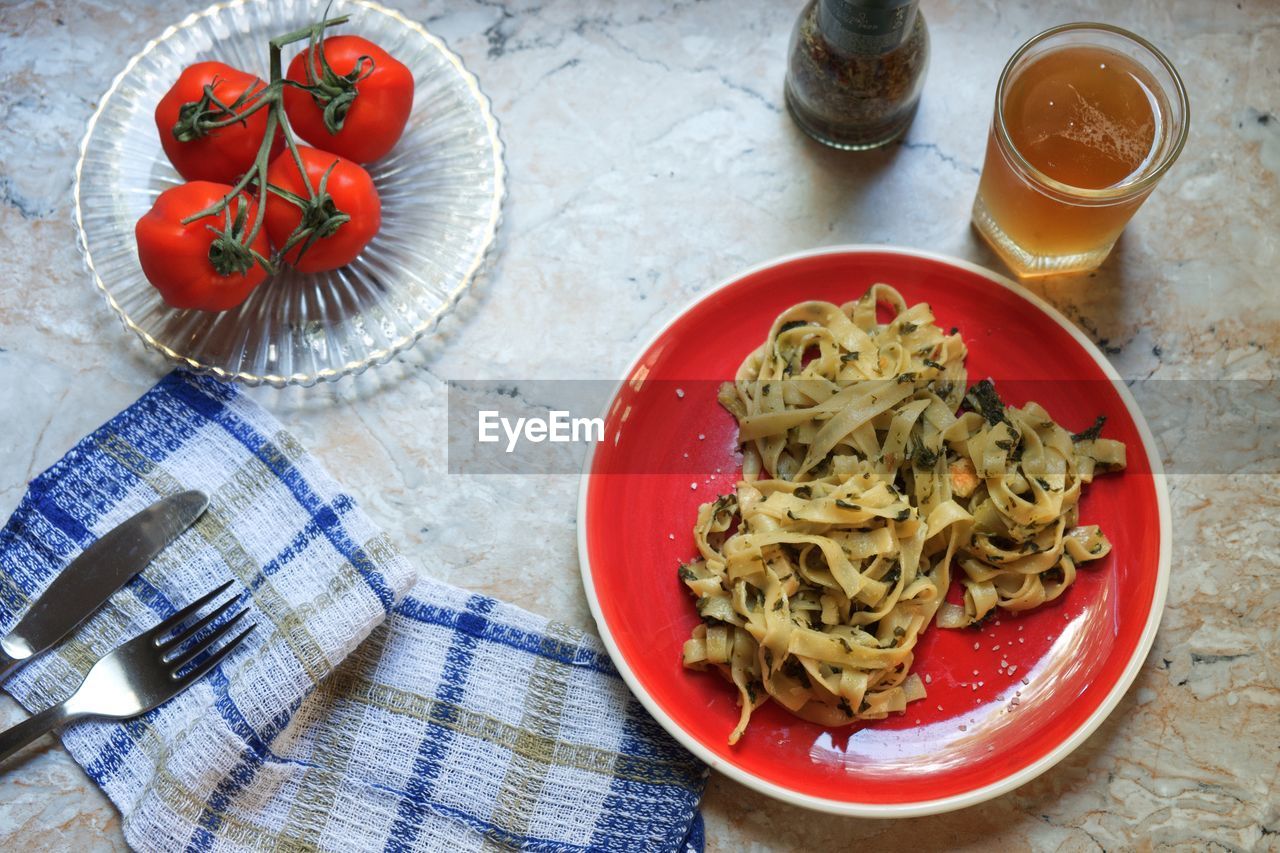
[{"x1": 680, "y1": 284, "x2": 1125, "y2": 743}]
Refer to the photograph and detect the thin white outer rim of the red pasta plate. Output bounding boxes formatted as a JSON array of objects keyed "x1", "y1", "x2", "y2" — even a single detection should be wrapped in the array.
[{"x1": 577, "y1": 243, "x2": 1172, "y2": 817}]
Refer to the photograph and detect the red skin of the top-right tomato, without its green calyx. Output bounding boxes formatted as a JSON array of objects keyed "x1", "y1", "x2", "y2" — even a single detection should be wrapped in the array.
[{"x1": 284, "y1": 36, "x2": 413, "y2": 163}]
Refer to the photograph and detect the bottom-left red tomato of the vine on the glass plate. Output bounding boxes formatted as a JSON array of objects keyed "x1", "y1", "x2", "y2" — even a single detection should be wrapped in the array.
[{"x1": 134, "y1": 181, "x2": 271, "y2": 311}]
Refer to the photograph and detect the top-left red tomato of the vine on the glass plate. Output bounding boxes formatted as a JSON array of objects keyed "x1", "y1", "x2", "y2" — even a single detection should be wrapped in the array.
[{"x1": 156, "y1": 63, "x2": 283, "y2": 183}]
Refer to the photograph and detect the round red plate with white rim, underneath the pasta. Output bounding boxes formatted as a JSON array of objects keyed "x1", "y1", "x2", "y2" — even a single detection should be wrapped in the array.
[{"x1": 579, "y1": 247, "x2": 1170, "y2": 817}]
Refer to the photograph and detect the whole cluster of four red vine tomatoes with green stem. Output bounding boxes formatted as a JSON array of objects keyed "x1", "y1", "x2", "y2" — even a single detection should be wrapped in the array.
[{"x1": 134, "y1": 24, "x2": 413, "y2": 311}]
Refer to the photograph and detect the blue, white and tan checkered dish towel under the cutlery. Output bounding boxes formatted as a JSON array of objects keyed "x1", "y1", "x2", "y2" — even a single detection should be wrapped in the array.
[{"x1": 0, "y1": 373, "x2": 705, "y2": 852}]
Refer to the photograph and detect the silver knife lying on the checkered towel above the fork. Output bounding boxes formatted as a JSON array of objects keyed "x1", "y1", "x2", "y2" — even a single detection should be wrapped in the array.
[{"x1": 0, "y1": 491, "x2": 209, "y2": 680}]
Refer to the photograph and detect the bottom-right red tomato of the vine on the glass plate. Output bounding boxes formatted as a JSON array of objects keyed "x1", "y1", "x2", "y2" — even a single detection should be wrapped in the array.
[{"x1": 266, "y1": 146, "x2": 383, "y2": 273}]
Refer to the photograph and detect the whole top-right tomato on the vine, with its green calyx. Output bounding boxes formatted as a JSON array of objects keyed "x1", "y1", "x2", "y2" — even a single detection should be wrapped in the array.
[{"x1": 284, "y1": 36, "x2": 413, "y2": 163}]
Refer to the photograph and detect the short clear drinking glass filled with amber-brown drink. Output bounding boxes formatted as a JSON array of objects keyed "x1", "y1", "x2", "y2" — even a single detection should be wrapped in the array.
[{"x1": 973, "y1": 23, "x2": 1189, "y2": 277}]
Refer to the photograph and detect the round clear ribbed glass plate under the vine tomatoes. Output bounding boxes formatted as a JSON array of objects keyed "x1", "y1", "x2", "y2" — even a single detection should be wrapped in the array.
[{"x1": 76, "y1": 0, "x2": 506, "y2": 387}]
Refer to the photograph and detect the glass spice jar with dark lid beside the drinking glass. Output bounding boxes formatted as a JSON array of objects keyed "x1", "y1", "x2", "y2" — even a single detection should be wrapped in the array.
[{"x1": 786, "y1": 0, "x2": 929, "y2": 151}]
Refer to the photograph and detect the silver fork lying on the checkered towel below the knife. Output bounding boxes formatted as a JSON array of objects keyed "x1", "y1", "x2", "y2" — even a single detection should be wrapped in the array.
[{"x1": 0, "y1": 580, "x2": 255, "y2": 761}]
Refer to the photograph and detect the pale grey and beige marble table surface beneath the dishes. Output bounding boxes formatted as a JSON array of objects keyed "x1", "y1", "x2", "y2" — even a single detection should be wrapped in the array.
[{"x1": 0, "y1": 0, "x2": 1280, "y2": 850}]
